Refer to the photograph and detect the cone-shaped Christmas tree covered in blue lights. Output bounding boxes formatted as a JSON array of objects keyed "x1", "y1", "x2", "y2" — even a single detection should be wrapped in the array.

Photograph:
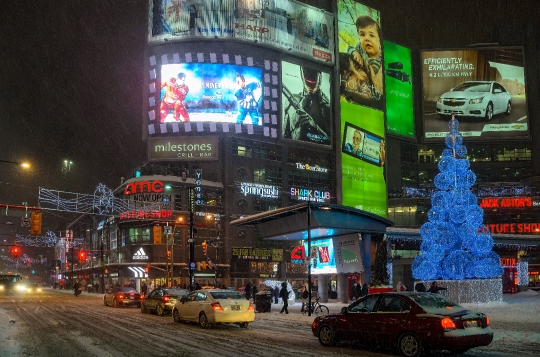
[{"x1": 412, "y1": 115, "x2": 503, "y2": 281}]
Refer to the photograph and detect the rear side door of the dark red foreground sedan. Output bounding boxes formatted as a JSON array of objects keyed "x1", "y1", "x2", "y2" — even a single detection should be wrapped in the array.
[{"x1": 377, "y1": 295, "x2": 411, "y2": 344}]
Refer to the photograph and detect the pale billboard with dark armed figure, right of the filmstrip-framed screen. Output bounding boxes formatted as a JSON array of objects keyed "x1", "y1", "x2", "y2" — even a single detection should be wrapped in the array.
[{"x1": 281, "y1": 61, "x2": 332, "y2": 145}]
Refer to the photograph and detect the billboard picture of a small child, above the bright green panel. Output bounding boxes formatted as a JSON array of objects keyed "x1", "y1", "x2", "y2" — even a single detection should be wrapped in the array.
[{"x1": 338, "y1": 0, "x2": 385, "y2": 110}]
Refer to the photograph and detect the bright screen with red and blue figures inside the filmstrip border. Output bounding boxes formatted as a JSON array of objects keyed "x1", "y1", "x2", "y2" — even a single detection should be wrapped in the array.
[{"x1": 160, "y1": 63, "x2": 262, "y2": 125}]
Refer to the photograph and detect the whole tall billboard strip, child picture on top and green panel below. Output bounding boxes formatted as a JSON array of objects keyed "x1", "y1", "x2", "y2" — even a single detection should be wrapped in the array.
[{"x1": 338, "y1": 0, "x2": 387, "y2": 217}]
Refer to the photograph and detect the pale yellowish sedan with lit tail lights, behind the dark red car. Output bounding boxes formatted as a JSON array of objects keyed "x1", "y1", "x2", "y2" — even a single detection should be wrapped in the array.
[{"x1": 172, "y1": 289, "x2": 255, "y2": 329}]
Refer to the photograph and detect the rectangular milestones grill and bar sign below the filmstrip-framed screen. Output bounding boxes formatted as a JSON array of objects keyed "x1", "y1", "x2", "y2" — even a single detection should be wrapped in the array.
[{"x1": 148, "y1": 136, "x2": 219, "y2": 161}]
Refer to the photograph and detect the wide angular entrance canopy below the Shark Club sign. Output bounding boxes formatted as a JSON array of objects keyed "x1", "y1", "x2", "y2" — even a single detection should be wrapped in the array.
[{"x1": 230, "y1": 202, "x2": 394, "y2": 240}]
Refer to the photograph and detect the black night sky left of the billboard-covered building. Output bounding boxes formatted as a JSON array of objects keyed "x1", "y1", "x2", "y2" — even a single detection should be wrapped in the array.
[{"x1": 0, "y1": 0, "x2": 148, "y2": 228}]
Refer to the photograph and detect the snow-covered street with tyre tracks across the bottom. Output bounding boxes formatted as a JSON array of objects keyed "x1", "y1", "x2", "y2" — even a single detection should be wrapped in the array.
[{"x1": 0, "y1": 289, "x2": 540, "y2": 357}]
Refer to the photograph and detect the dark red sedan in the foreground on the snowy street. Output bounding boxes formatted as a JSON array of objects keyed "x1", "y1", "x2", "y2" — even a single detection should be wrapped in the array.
[{"x1": 311, "y1": 292, "x2": 493, "y2": 357}]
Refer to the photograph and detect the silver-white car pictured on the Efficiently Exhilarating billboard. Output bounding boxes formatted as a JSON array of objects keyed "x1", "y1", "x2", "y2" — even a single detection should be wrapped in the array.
[{"x1": 437, "y1": 81, "x2": 512, "y2": 120}]
